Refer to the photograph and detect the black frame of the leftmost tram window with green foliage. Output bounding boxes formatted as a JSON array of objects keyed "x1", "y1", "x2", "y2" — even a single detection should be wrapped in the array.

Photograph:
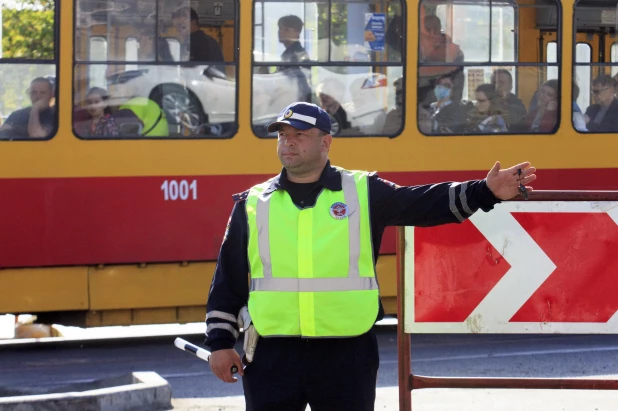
[{"x1": 0, "y1": 0, "x2": 62, "y2": 143}]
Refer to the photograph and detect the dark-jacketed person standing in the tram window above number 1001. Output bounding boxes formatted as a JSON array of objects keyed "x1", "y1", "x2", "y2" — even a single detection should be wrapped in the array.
[{"x1": 172, "y1": 7, "x2": 224, "y2": 62}]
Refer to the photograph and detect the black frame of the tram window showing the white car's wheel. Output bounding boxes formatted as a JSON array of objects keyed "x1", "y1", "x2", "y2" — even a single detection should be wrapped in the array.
[{"x1": 70, "y1": 0, "x2": 241, "y2": 141}]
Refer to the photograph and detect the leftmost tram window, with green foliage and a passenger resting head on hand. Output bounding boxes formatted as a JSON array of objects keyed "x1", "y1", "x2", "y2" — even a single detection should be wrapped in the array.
[{"x1": 0, "y1": 0, "x2": 58, "y2": 141}]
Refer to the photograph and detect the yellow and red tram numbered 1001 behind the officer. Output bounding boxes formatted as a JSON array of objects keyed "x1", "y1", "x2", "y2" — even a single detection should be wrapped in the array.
[{"x1": 0, "y1": 0, "x2": 618, "y2": 327}]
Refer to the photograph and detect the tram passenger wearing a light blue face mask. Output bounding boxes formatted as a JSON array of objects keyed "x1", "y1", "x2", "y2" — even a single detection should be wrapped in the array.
[{"x1": 429, "y1": 75, "x2": 467, "y2": 134}]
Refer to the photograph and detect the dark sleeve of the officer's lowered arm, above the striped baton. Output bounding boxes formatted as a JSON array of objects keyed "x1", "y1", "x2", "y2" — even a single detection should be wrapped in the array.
[{"x1": 205, "y1": 199, "x2": 249, "y2": 351}]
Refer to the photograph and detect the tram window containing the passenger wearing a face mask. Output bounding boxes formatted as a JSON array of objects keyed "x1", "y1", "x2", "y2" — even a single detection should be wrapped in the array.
[{"x1": 417, "y1": 0, "x2": 560, "y2": 135}]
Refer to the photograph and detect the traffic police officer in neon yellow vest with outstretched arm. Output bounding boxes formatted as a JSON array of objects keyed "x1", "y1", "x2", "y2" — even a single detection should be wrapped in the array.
[{"x1": 206, "y1": 102, "x2": 536, "y2": 411}]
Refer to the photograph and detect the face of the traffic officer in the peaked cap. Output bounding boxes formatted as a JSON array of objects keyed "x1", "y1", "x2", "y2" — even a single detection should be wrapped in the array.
[{"x1": 277, "y1": 124, "x2": 332, "y2": 173}]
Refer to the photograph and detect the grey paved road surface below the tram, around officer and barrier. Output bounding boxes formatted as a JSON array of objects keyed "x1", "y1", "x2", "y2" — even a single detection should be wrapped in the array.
[{"x1": 0, "y1": 327, "x2": 618, "y2": 411}]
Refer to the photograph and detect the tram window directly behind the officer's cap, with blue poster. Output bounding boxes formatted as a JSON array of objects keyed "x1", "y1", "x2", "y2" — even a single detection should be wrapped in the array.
[{"x1": 252, "y1": 0, "x2": 405, "y2": 137}]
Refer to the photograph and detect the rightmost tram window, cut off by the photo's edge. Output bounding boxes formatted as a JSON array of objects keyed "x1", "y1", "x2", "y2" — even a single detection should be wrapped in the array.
[{"x1": 573, "y1": 0, "x2": 618, "y2": 133}]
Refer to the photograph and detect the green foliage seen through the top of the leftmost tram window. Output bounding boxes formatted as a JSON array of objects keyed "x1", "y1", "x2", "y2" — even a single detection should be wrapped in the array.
[{"x1": 2, "y1": 0, "x2": 54, "y2": 60}]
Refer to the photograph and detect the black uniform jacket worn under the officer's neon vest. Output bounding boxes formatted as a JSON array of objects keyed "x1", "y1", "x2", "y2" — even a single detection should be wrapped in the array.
[{"x1": 206, "y1": 162, "x2": 500, "y2": 351}]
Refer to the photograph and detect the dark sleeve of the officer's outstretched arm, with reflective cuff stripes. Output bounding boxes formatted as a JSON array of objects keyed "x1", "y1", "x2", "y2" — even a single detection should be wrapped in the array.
[{"x1": 369, "y1": 174, "x2": 500, "y2": 227}]
